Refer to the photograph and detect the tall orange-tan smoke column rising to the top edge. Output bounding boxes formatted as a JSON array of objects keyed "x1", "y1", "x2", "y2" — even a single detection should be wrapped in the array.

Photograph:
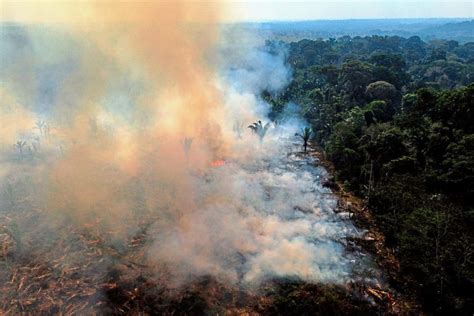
[{"x1": 54, "y1": 1, "x2": 231, "y2": 232}]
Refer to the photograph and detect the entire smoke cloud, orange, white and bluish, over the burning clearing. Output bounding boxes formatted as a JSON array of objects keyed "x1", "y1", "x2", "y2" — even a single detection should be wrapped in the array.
[{"x1": 0, "y1": 1, "x2": 362, "y2": 296}]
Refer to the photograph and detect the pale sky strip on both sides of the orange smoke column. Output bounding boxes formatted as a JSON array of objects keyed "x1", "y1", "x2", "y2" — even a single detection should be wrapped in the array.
[{"x1": 0, "y1": 0, "x2": 474, "y2": 22}]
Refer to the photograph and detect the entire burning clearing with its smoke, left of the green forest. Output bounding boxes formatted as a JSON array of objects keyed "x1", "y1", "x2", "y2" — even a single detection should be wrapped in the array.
[{"x1": 0, "y1": 1, "x2": 414, "y2": 314}]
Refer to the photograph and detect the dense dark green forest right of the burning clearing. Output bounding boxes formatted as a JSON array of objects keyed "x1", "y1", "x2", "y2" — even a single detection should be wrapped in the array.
[{"x1": 263, "y1": 36, "x2": 474, "y2": 314}]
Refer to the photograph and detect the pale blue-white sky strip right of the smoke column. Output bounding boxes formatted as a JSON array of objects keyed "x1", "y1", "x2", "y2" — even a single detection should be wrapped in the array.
[{"x1": 229, "y1": 0, "x2": 474, "y2": 21}]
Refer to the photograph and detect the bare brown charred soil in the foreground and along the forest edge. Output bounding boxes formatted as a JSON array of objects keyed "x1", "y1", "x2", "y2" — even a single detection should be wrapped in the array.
[{"x1": 0, "y1": 143, "x2": 419, "y2": 315}]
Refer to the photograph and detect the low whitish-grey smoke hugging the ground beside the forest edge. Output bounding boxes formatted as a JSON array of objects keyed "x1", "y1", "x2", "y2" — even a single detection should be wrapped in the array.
[{"x1": 146, "y1": 160, "x2": 349, "y2": 284}]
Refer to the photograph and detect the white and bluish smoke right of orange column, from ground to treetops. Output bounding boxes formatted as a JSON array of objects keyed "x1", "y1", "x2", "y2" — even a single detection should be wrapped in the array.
[{"x1": 143, "y1": 29, "x2": 362, "y2": 285}]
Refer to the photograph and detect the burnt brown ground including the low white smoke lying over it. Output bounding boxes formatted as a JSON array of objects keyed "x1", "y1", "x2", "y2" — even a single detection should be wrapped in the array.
[{"x1": 0, "y1": 135, "x2": 387, "y2": 314}]
